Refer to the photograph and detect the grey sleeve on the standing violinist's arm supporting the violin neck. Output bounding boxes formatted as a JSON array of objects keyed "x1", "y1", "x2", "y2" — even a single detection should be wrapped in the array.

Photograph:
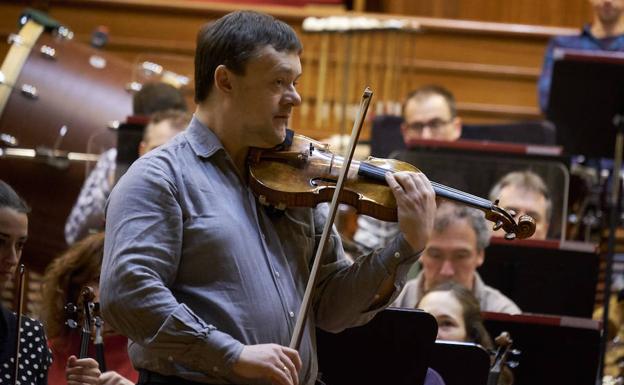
[{"x1": 314, "y1": 208, "x2": 420, "y2": 332}]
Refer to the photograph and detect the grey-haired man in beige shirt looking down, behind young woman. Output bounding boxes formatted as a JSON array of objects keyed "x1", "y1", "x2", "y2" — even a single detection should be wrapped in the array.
[{"x1": 394, "y1": 202, "x2": 520, "y2": 314}]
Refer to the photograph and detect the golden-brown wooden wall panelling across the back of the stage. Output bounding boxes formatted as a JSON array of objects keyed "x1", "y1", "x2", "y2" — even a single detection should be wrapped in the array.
[{"x1": 0, "y1": 0, "x2": 574, "y2": 137}]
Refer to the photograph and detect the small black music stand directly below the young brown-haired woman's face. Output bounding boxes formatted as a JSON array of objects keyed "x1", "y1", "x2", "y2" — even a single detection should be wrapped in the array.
[{"x1": 429, "y1": 341, "x2": 490, "y2": 385}]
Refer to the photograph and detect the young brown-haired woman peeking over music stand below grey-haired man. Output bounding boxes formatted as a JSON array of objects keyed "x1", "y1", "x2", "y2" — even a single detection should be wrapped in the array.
[{"x1": 416, "y1": 281, "x2": 513, "y2": 385}]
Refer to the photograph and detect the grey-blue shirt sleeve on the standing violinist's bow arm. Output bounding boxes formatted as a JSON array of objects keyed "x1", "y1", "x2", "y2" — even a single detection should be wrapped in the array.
[{"x1": 100, "y1": 158, "x2": 243, "y2": 376}]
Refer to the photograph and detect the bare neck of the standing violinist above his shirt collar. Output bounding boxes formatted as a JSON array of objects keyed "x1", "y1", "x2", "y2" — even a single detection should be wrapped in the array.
[{"x1": 195, "y1": 105, "x2": 249, "y2": 180}]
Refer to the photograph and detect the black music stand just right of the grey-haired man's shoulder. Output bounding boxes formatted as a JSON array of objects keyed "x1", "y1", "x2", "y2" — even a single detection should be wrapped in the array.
[{"x1": 479, "y1": 237, "x2": 600, "y2": 318}]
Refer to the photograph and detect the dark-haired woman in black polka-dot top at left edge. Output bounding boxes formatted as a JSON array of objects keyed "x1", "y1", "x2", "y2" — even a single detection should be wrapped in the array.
[{"x1": 0, "y1": 180, "x2": 52, "y2": 385}]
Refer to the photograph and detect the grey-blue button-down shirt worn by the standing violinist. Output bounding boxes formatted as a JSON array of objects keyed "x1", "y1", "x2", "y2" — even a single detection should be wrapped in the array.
[{"x1": 100, "y1": 118, "x2": 418, "y2": 384}]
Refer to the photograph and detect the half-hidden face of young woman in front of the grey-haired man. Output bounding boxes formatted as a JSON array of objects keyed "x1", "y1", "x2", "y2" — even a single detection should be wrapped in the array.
[{"x1": 418, "y1": 291, "x2": 467, "y2": 342}]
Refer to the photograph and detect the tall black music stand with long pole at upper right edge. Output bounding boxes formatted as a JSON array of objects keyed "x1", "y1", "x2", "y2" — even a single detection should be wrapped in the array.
[{"x1": 547, "y1": 49, "x2": 624, "y2": 376}]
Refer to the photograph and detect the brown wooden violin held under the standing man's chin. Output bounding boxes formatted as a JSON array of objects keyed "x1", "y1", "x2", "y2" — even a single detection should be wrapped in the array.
[{"x1": 249, "y1": 130, "x2": 535, "y2": 239}]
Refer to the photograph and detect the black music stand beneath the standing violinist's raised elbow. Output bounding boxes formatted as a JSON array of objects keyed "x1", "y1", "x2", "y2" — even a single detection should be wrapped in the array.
[{"x1": 316, "y1": 309, "x2": 438, "y2": 385}]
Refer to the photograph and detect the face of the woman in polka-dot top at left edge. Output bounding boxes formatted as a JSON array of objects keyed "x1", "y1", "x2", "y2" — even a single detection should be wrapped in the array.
[{"x1": 0, "y1": 207, "x2": 28, "y2": 289}]
